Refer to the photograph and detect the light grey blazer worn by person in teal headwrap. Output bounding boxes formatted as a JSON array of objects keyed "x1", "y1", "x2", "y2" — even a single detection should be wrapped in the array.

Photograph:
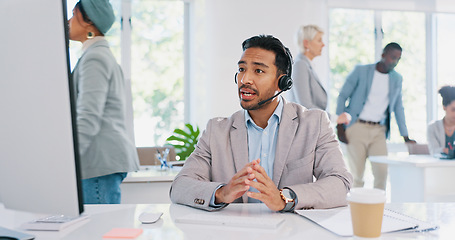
[{"x1": 73, "y1": 40, "x2": 139, "y2": 179}]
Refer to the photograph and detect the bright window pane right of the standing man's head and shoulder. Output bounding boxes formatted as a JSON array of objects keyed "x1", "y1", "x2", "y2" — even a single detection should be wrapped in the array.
[{"x1": 382, "y1": 11, "x2": 427, "y2": 142}]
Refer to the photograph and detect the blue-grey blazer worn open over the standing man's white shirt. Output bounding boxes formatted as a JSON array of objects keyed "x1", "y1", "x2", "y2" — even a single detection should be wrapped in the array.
[{"x1": 336, "y1": 64, "x2": 408, "y2": 136}]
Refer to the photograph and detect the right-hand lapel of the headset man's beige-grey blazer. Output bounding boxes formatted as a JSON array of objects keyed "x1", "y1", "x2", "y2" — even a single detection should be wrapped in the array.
[{"x1": 272, "y1": 102, "x2": 298, "y2": 187}]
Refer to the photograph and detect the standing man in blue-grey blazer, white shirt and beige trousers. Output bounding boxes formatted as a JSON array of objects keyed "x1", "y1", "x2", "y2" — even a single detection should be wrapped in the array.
[{"x1": 336, "y1": 42, "x2": 415, "y2": 189}]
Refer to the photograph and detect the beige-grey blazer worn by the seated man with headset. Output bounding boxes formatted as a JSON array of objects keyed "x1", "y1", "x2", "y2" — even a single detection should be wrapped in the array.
[{"x1": 170, "y1": 102, "x2": 352, "y2": 210}]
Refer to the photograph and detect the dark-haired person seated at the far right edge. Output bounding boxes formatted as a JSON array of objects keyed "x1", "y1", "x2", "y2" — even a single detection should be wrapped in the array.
[{"x1": 427, "y1": 86, "x2": 455, "y2": 155}]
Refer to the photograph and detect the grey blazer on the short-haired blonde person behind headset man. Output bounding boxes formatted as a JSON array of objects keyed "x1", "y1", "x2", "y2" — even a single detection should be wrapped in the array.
[{"x1": 287, "y1": 54, "x2": 327, "y2": 110}]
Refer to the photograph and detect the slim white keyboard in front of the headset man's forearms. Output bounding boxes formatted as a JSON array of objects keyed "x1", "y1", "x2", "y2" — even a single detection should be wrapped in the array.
[{"x1": 175, "y1": 214, "x2": 284, "y2": 229}]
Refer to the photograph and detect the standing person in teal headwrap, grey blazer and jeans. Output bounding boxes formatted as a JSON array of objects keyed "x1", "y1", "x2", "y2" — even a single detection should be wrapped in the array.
[{"x1": 68, "y1": 0, "x2": 139, "y2": 204}]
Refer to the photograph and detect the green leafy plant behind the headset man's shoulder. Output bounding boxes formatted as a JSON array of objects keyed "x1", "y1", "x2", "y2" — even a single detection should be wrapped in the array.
[{"x1": 166, "y1": 123, "x2": 200, "y2": 161}]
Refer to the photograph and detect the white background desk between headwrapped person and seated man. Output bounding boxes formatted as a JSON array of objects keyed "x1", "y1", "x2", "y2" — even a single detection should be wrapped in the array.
[{"x1": 120, "y1": 166, "x2": 182, "y2": 204}]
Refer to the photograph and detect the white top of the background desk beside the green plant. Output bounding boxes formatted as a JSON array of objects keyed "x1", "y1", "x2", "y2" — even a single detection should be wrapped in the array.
[{"x1": 123, "y1": 166, "x2": 182, "y2": 183}]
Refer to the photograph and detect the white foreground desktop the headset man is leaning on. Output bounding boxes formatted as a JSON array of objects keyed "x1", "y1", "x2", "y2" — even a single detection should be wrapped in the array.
[{"x1": 0, "y1": 203, "x2": 455, "y2": 240}]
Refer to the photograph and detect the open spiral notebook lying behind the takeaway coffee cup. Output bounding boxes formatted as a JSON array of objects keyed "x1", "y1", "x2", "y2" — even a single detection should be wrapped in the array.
[{"x1": 296, "y1": 207, "x2": 437, "y2": 237}]
